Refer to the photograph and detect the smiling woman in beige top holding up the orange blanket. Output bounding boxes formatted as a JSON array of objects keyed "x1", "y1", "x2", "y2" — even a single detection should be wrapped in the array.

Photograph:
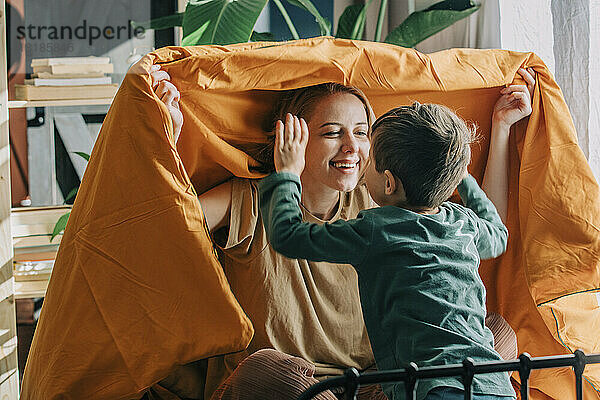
[{"x1": 152, "y1": 66, "x2": 528, "y2": 399}]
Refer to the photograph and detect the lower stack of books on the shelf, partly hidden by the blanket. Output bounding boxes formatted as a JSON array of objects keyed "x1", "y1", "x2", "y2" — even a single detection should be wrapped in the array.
[{"x1": 10, "y1": 206, "x2": 71, "y2": 291}]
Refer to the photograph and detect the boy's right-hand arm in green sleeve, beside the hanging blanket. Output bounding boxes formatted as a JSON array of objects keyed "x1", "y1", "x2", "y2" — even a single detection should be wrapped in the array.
[{"x1": 458, "y1": 175, "x2": 508, "y2": 259}]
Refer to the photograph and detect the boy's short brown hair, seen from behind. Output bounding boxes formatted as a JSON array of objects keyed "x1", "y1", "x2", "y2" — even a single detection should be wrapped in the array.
[{"x1": 373, "y1": 102, "x2": 475, "y2": 208}]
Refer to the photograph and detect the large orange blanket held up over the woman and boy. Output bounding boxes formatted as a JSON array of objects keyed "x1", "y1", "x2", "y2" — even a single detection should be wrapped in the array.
[{"x1": 21, "y1": 38, "x2": 600, "y2": 400}]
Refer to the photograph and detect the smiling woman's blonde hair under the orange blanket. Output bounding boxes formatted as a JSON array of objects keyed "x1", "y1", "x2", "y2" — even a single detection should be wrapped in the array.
[{"x1": 254, "y1": 82, "x2": 375, "y2": 173}]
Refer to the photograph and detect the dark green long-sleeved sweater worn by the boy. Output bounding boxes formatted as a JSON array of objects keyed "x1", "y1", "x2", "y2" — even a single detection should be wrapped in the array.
[{"x1": 259, "y1": 173, "x2": 515, "y2": 400}]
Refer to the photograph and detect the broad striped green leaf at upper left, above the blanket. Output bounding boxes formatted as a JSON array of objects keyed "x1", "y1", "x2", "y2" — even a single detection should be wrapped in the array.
[{"x1": 182, "y1": 0, "x2": 268, "y2": 46}]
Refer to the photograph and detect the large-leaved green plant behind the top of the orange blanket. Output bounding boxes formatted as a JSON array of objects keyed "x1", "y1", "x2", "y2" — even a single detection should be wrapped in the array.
[{"x1": 132, "y1": 0, "x2": 480, "y2": 47}]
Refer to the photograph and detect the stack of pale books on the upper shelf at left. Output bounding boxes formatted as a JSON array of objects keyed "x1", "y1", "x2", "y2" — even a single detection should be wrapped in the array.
[{"x1": 15, "y1": 57, "x2": 118, "y2": 100}]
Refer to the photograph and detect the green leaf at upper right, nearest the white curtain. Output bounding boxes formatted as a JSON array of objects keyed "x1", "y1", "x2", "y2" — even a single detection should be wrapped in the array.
[{"x1": 385, "y1": 0, "x2": 480, "y2": 47}]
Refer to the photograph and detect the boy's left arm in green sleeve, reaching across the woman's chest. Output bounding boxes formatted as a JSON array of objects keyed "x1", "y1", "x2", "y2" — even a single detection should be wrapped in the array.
[{"x1": 258, "y1": 172, "x2": 372, "y2": 265}]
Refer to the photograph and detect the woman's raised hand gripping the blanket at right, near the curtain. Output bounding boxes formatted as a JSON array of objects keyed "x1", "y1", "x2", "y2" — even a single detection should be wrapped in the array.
[{"x1": 492, "y1": 68, "x2": 535, "y2": 128}]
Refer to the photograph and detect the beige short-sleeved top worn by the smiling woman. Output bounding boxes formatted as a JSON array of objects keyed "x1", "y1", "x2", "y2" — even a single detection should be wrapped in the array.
[{"x1": 206, "y1": 179, "x2": 375, "y2": 398}]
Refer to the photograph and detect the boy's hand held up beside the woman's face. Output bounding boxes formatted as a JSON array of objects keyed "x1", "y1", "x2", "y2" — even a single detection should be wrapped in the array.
[{"x1": 274, "y1": 113, "x2": 308, "y2": 176}]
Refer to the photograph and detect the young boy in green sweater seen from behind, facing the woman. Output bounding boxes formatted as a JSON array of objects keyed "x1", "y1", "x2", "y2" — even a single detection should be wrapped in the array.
[{"x1": 259, "y1": 81, "x2": 531, "y2": 400}]
